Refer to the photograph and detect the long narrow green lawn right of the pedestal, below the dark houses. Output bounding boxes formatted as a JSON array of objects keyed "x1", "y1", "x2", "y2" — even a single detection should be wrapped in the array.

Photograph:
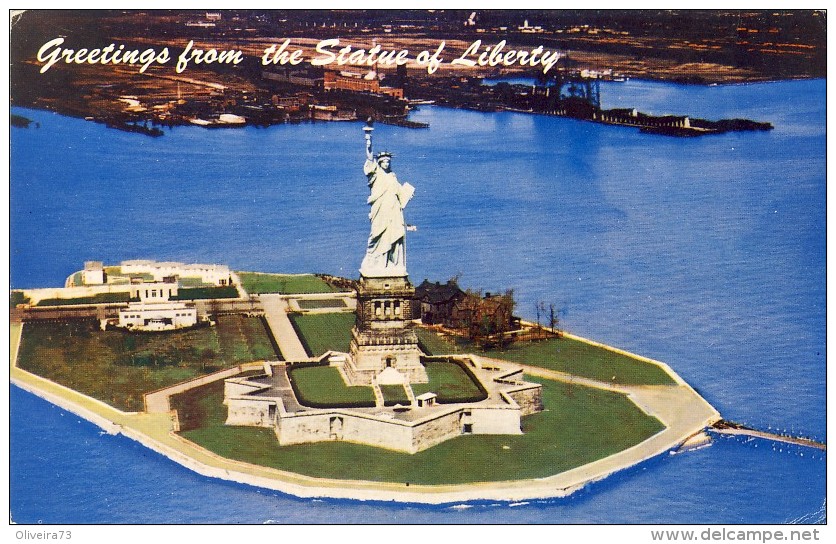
[{"x1": 416, "y1": 327, "x2": 676, "y2": 385}]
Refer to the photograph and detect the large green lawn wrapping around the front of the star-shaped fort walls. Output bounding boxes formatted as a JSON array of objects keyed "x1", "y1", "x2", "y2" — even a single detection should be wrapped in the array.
[{"x1": 177, "y1": 374, "x2": 663, "y2": 484}]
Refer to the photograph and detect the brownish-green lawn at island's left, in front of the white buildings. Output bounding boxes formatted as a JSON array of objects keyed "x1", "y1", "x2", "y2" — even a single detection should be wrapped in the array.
[{"x1": 18, "y1": 316, "x2": 276, "y2": 411}]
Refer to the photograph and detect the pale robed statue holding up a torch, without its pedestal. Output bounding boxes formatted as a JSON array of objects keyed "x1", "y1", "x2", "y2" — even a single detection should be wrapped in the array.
[{"x1": 360, "y1": 120, "x2": 415, "y2": 277}]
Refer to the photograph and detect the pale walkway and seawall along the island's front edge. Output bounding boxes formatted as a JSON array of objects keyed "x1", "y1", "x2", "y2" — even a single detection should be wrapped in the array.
[{"x1": 10, "y1": 320, "x2": 720, "y2": 505}]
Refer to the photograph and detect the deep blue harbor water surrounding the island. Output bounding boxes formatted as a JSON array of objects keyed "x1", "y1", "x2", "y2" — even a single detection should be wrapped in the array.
[{"x1": 10, "y1": 80, "x2": 826, "y2": 523}]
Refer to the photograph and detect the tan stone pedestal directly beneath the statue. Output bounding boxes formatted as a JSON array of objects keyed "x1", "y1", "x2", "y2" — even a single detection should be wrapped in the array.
[{"x1": 345, "y1": 275, "x2": 428, "y2": 385}]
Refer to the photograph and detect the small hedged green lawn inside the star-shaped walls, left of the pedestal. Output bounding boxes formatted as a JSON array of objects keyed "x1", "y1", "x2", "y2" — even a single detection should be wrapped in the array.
[{"x1": 287, "y1": 366, "x2": 376, "y2": 408}]
